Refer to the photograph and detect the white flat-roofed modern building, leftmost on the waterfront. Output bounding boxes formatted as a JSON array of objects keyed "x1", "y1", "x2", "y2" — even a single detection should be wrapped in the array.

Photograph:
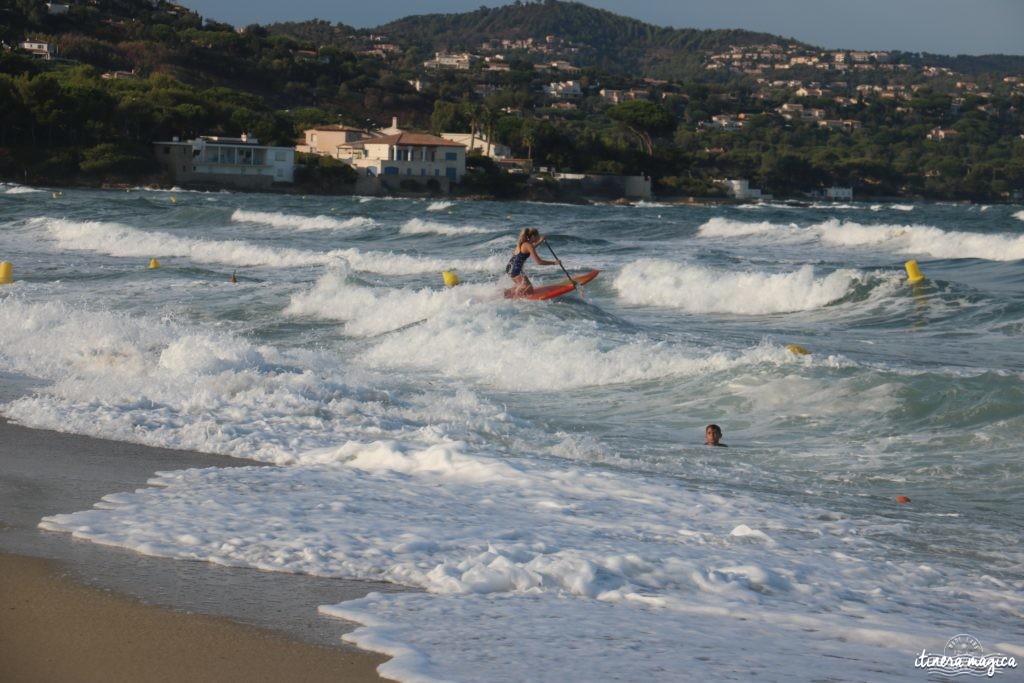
[{"x1": 154, "y1": 133, "x2": 295, "y2": 189}]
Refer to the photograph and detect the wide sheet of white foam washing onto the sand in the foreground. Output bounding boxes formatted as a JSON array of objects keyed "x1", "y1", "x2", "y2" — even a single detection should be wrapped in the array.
[{"x1": 34, "y1": 440, "x2": 1021, "y2": 681}]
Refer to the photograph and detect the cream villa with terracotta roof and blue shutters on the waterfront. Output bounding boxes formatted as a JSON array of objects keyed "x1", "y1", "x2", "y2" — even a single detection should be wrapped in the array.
[{"x1": 349, "y1": 131, "x2": 466, "y2": 186}]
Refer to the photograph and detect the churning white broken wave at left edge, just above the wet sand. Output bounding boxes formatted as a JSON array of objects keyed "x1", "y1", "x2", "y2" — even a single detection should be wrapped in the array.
[{"x1": 0, "y1": 298, "x2": 516, "y2": 465}]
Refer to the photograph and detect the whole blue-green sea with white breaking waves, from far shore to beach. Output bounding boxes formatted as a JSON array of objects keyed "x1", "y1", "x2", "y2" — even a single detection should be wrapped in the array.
[{"x1": 0, "y1": 185, "x2": 1024, "y2": 681}]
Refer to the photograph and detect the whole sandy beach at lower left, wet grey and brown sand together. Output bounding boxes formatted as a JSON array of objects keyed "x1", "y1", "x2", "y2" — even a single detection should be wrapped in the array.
[{"x1": 0, "y1": 420, "x2": 393, "y2": 683}]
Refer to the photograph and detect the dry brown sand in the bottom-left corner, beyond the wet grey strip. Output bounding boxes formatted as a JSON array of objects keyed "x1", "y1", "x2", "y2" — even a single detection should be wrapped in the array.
[{"x1": 0, "y1": 553, "x2": 386, "y2": 683}]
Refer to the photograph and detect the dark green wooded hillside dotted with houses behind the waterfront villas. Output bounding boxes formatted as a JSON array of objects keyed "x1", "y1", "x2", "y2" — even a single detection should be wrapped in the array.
[{"x1": 0, "y1": 0, "x2": 1024, "y2": 201}]
